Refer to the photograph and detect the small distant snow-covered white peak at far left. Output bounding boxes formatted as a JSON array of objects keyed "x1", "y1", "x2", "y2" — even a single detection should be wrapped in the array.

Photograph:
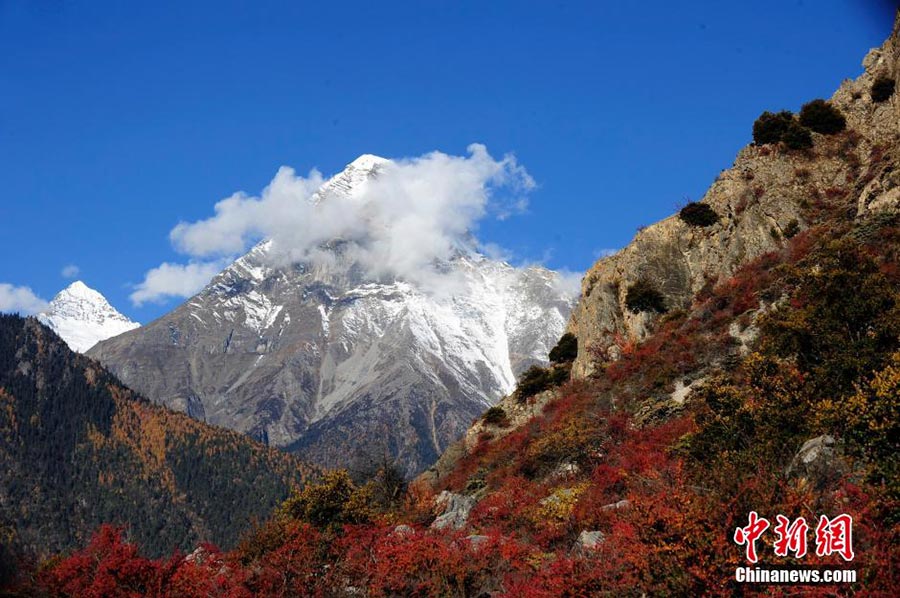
[{"x1": 37, "y1": 280, "x2": 140, "y2": 353}]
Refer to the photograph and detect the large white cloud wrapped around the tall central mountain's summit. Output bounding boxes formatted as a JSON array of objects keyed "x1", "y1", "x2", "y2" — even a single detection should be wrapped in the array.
[{"x1": 151, "y1": 144, "x2": 535, "y2": 296}]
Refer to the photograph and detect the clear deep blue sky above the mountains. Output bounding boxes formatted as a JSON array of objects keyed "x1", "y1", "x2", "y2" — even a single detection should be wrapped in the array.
[{"x1": 0, "y1": 0, "x2": 892, "y2": 322}]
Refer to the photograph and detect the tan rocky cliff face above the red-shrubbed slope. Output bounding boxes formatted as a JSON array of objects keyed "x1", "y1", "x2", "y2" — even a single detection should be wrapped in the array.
[{"x1": 568, "y1": 21, "x2": 900, "y2": 378}]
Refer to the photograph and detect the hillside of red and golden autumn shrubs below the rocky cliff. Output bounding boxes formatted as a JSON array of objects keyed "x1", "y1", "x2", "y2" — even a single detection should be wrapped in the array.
[{"x1": 15, "y1": 158, "x2": 900, "y2": 596}]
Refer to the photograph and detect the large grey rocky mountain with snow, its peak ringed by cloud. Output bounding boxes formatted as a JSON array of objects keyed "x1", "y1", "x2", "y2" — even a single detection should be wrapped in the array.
[{"x1": 90, "y1": 155, "x2": 575, "y2": 474}]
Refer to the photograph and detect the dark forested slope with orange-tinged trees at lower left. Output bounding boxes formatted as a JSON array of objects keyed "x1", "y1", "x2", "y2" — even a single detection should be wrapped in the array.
[{"x1": 0, "y1": 315, "x2": 309, "y2": 576}]
